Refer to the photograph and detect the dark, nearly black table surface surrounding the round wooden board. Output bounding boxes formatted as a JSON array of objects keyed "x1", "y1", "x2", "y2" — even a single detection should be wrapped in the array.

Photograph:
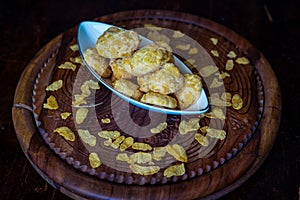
[{"x1": 0, "y1": 0, "x2": 300, "y2": 200}]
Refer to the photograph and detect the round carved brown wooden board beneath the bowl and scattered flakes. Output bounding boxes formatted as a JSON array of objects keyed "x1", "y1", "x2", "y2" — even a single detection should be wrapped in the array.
[{"x1": 12, "y1": 10, "x2": 281, "y2": 199}]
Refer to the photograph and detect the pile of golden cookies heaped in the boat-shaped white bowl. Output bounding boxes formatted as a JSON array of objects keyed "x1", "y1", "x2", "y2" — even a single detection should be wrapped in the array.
[{"x1": 84, "y1": 27, "x2": 202, "y2": 109}]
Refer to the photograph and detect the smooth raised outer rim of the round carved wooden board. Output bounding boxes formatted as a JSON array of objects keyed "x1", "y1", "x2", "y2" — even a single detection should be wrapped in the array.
[{"x1": 12, "y1": 10, "x2": 281, "y2": 199}]
